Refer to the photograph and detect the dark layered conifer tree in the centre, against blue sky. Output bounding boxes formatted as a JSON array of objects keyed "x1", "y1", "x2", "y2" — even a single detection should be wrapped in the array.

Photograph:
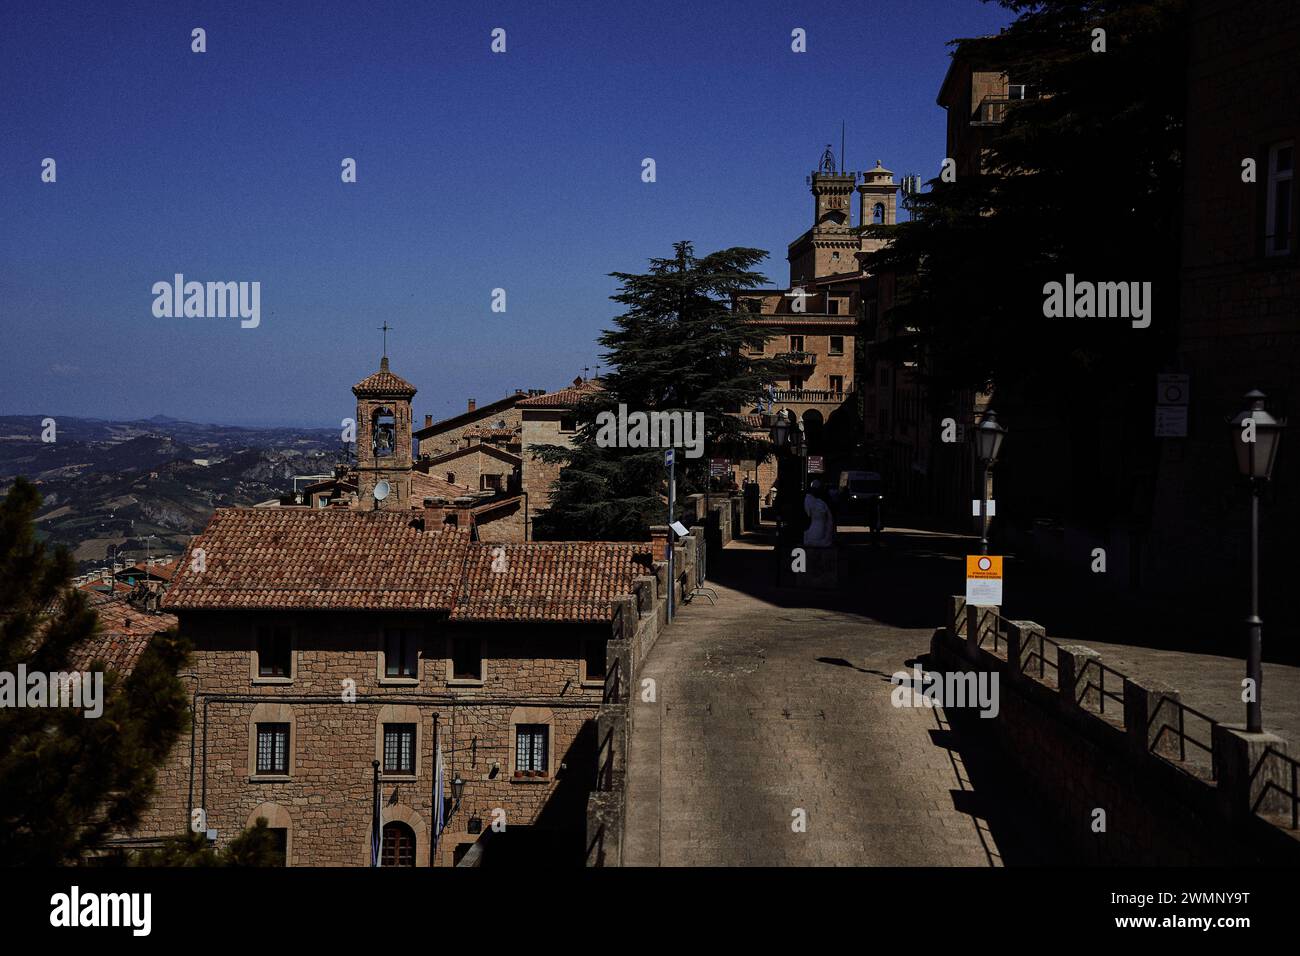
[{"x1": 528, "y1": 242, "x2": 780, "y2": 540}]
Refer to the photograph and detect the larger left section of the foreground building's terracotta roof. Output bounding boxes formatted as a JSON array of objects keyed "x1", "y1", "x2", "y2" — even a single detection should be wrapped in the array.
[{"x1": 163, "y1": 509, "x2": 469, "y2": 610}]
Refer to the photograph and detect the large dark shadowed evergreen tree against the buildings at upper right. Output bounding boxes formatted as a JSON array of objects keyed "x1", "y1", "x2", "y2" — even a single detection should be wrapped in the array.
[{"x1": 867, "y1": 0, "x2": 1187, "y2": 397}]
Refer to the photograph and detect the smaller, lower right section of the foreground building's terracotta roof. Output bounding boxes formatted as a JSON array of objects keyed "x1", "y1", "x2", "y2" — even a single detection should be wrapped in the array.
[{"x1": 451, "y1": 541, "x2": 651, "y2": 622}]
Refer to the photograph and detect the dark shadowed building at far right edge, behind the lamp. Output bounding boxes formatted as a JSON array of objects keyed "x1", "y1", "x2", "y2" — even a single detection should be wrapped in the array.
[{"x1": 1147, "y1": 0, "x2": 1300, "y2": 606}]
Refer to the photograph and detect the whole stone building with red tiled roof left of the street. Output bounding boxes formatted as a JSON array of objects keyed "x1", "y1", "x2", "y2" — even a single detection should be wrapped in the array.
[{"x1": 146, "y1": 509, "x2": 650, "y2": 866}]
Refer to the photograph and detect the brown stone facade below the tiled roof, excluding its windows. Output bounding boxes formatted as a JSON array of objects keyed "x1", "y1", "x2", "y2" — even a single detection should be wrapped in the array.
[{"x1": 133, "y1": 613, "x2": 608, "y2": 866}]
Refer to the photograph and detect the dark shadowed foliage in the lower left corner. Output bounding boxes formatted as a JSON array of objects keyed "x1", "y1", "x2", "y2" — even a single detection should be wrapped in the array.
[{"x1": 0, "y1": 479, "x2": 190, "y2": 866}]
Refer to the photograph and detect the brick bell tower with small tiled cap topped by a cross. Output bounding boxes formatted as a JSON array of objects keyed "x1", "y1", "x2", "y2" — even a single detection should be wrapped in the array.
[{"x1": 352, "y1": 355, "x2": 416, "y2": 511}]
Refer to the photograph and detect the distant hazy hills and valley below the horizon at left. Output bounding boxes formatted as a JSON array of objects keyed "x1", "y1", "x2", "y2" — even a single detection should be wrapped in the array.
[{"x1": 0, "y1": 415, "x2": 342, "y2": 571}]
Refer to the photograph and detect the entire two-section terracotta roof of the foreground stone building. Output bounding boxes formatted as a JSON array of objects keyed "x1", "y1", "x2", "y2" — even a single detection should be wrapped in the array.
[{"x1": 157, "y1": 512, "x2": 653, "y2": 624}]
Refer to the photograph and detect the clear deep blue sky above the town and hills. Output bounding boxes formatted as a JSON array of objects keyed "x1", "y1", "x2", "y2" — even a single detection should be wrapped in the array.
[{"x1": 0, "y1": 0, "x2": 1010, "y2": 425}]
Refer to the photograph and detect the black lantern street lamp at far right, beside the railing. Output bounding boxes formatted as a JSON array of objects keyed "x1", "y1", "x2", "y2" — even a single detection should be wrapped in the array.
[{"x1": 1232, "y1": 389, "x2": 1287, "y2": 734}]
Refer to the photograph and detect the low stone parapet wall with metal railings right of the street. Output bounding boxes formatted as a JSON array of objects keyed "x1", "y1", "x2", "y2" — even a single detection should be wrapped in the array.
[{"x1": 928, "y1": 597, "x2": 1300, "y2": 866}]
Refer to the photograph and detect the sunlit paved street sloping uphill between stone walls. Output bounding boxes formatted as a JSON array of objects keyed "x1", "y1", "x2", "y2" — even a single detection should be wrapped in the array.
[{"x1": 624, "y1": 536, "x2": 1060, "y2": 866}]
